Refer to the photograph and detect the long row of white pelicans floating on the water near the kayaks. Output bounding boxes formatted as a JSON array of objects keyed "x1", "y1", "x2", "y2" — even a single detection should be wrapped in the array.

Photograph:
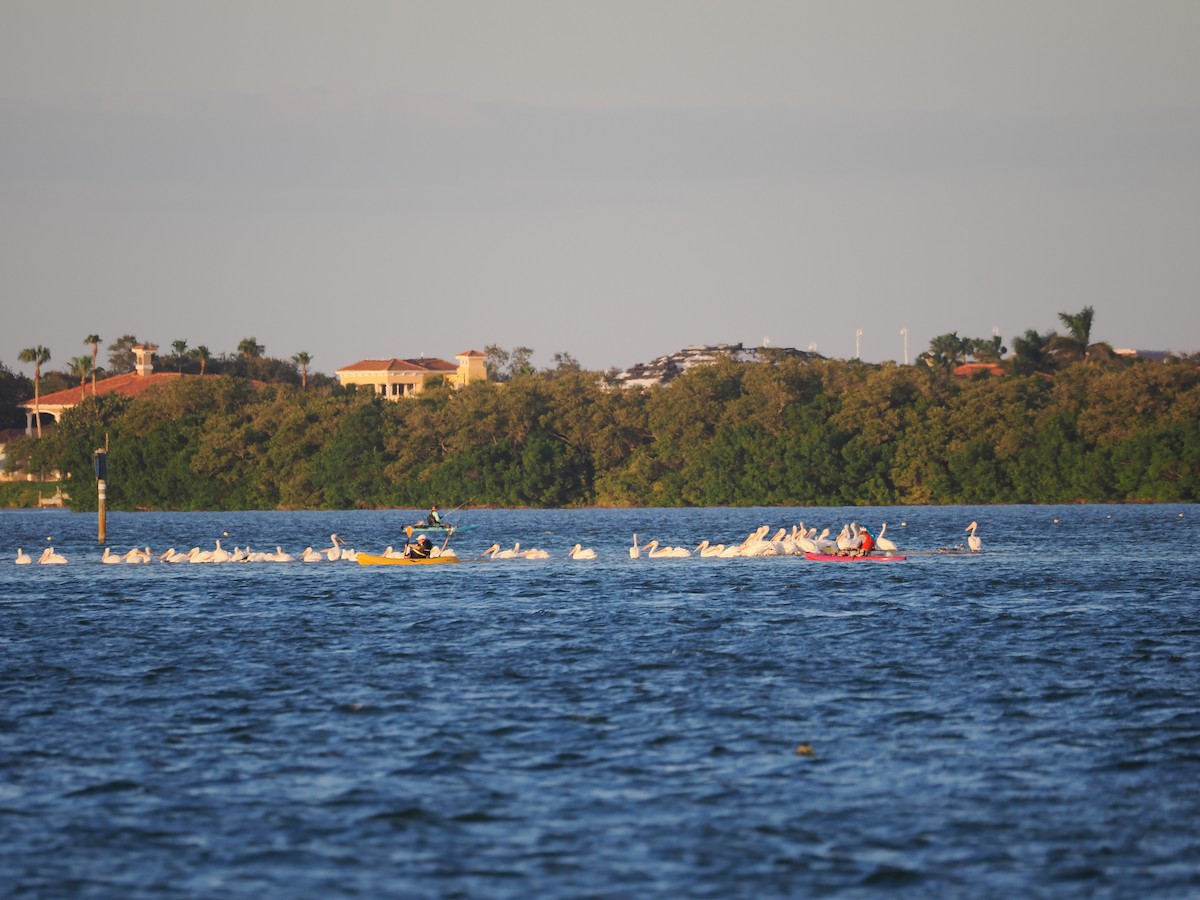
[{"x1": 9, "y1": 522, "x2": 983, "y2": 565}]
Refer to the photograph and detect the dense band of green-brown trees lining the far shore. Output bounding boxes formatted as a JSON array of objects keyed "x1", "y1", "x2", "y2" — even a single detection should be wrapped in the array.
[{"x1": 0, "y1": 355, "x2": 1200, "y2": 511}]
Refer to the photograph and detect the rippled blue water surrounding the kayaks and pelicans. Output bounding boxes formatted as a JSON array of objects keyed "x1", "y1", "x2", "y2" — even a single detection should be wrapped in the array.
[{"x1": 0, "y1": 505, "x2": 1200, "y2": 898}]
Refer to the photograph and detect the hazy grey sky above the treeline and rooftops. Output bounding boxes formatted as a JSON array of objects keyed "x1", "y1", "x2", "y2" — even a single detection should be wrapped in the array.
[{"x1": 0, "y1": 0, "x2": 1200, "y2": 374}]
